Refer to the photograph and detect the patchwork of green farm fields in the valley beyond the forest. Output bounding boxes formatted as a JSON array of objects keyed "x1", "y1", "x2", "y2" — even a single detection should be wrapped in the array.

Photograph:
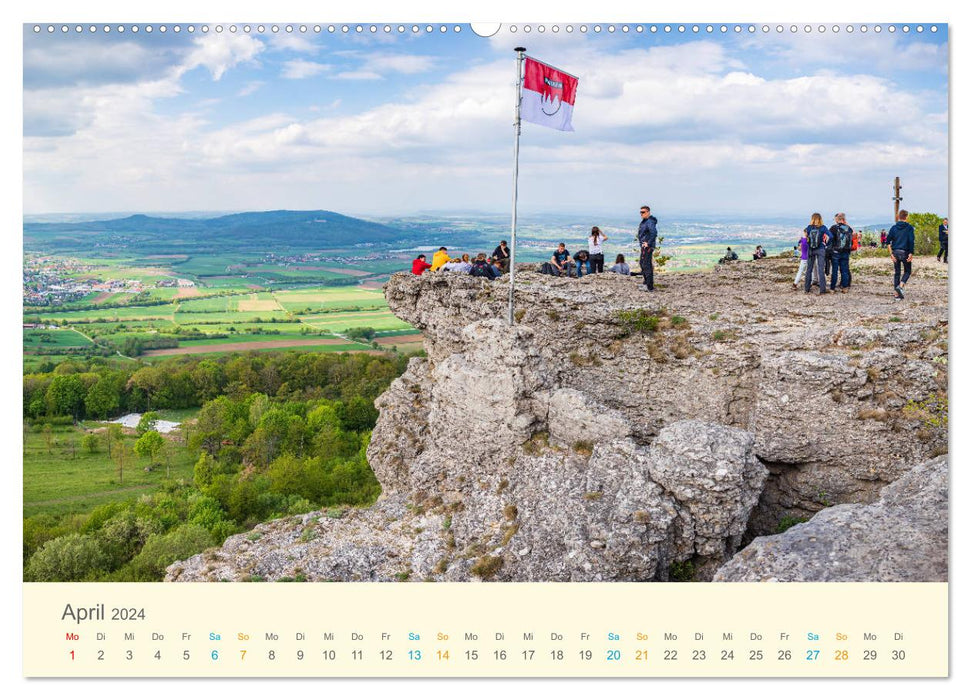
[{"x1": 24, "y1": 249, "x2": 417, "y2": 371}]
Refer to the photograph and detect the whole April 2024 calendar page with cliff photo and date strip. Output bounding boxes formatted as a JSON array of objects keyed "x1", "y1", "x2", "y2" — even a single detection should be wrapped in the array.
[{"x1": 18, "y1": 8, "x2": 950, "y2": 678}]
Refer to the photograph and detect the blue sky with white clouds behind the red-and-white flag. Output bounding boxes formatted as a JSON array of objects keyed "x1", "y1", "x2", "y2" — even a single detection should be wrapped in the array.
[{"x1": 24, "y1": 24, "x2": 948, "y2": 219}]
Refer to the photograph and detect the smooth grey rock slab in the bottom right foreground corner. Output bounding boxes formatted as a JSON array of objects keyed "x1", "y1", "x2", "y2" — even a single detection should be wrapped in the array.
[{"x1": 714, "y1": 457, "x2": 948, "y2": 581}]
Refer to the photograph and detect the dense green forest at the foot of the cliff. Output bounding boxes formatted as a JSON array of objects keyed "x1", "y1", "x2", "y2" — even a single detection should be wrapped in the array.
[{"x1": 23, "y1": 352, "x2": 407, "y2": 581}]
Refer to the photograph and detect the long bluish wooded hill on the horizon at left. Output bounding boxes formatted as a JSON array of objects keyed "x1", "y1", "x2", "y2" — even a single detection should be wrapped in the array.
[{"x1": 24, "y1": 210, "x2": 414, "y2": 254}]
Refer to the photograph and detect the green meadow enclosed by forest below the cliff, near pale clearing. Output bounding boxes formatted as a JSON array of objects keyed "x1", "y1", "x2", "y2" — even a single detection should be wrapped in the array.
[{"x1": 23, "y1": 422, "x2": 195, "y2": 517}]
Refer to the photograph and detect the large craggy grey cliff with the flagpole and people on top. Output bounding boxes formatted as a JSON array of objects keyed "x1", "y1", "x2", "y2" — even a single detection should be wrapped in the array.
[{"x1": 168, "y1": 254, "x2": 947, "y2": 581}]
